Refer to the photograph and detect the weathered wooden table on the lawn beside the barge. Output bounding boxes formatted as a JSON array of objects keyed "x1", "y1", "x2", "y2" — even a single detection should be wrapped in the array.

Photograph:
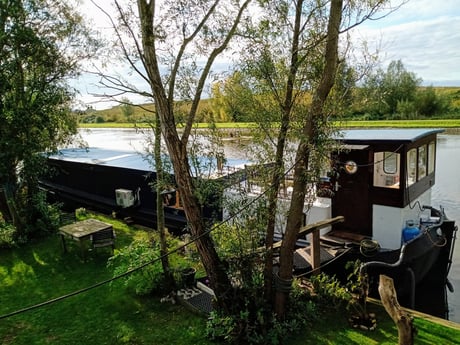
[{"x1": 59, "y1": 219, "x2": 112, "y2": 258}]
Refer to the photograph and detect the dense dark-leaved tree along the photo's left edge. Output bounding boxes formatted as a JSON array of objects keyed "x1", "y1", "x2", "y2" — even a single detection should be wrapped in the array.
[{"x1": 0, "y1": 0, "x2": 95, "y2": 235}]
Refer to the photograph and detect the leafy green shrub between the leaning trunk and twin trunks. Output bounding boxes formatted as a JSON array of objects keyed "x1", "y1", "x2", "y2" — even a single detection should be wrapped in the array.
[{"x1": 207, "y1": 220, "x2": 283, "y2": 344}]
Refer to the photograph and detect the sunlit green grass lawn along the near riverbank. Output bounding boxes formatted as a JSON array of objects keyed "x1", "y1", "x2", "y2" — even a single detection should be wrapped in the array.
[{"x1": 0, "y1": 214, "x2": 460, "y2": 345}]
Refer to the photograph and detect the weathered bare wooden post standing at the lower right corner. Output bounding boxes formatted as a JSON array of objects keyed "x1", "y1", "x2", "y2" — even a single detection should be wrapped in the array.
[{"x1": 379, "y1": 274, "x2": 415, "y2": 345}]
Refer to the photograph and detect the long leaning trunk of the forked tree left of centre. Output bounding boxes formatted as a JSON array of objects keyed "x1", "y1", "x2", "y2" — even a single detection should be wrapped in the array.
[{"x1": 137, "y1": 0, "x2": 231, "y2": 311}]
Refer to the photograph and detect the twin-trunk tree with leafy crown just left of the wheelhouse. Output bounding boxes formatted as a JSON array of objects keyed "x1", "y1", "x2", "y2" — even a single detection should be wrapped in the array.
[{"x1": 234, "y1": 0, "x2": 402, "y2": 317}]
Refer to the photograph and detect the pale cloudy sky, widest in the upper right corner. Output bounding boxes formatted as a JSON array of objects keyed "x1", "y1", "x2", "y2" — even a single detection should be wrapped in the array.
[{"x1": 72, "y1": 0, "x2": 460, "y2": 109}]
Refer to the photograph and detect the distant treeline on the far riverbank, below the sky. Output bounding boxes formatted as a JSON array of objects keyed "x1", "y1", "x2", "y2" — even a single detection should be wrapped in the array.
[{"x1": 77, "y1": 86, "x2": 460, "y2": 124}]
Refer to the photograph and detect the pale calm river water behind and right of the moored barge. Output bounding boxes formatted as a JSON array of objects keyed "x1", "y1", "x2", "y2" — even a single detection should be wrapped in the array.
[{"x1": 76, "y1": 129, "x2": 460, "y2": 323}]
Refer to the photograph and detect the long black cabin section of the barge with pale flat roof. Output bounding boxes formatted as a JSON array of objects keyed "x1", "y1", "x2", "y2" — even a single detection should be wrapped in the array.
[{"x1": 39, "y1": 147, "x2": 245, "y2": 234}]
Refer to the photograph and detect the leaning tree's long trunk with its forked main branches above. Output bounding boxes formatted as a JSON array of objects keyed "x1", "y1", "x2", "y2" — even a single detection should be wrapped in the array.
[{"x1": 138, "y1": 0, "x2": 249, "y2": 310}]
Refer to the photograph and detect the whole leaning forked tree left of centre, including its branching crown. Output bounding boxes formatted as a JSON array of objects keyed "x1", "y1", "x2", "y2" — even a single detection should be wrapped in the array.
[{"x1": 94, "y1": 0, "x2": 250, "y2": 309}]
